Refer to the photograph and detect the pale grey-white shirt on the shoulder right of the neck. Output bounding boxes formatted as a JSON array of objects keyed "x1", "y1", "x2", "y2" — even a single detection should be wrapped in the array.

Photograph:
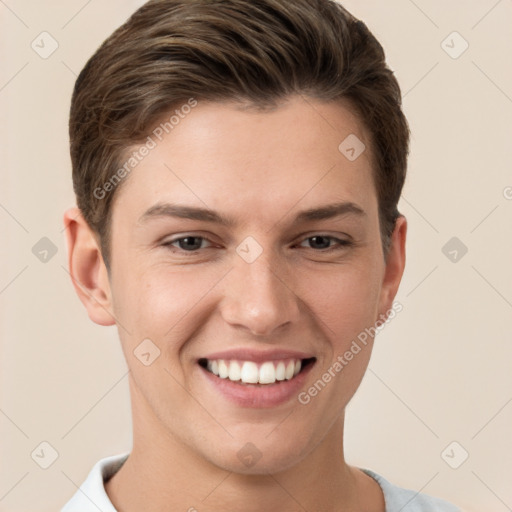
[{"x1": 360, "y1": 468, "x2": 462, "y2": 512}]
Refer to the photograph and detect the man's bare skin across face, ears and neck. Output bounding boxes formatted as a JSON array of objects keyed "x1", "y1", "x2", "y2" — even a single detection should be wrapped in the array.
[{"x1": 65, "y1": 96, "x2": 407, "y2": 512}]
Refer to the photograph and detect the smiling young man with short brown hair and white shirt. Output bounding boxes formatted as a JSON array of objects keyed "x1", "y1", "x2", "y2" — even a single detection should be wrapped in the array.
[{"x1": 63, "y1": 0, "x2": 457, "y2": 512}]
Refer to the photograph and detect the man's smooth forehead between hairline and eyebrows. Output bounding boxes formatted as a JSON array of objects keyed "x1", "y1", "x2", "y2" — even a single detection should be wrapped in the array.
[{"x1": 114, "y1": 96, "x2": 375, "y2": 226}]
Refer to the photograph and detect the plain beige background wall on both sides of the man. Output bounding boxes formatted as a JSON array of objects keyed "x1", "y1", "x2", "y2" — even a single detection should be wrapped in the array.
[{"x1": 0, "y1": 0, "x2": 512, "y2": 512}]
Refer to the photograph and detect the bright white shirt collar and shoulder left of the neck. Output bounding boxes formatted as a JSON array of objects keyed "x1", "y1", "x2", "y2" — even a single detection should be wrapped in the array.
[{"x1": 61, "y1": 453, "x2": 129, "y2": 512}]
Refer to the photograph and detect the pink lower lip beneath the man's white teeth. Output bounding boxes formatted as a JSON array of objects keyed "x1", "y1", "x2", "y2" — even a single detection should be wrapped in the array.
[{"x1": 198, "y1": 363, "x2": 315, "y2": 408}]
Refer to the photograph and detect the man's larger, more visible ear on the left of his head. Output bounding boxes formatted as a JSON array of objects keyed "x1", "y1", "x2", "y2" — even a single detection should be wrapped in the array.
[{"x1": 64, "y1": 208, "x2": 115, "y2": 325}]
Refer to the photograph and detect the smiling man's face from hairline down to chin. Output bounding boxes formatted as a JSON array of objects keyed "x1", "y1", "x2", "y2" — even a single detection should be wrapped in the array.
[{"x1": 93, "y1": 97, "x2": 403, "y2": 473}]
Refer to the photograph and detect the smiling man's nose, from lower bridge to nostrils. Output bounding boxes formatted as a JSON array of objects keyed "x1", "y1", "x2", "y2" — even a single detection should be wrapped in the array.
[{"x1": 220, "y1": 251, "x2": 300, "y2": 337}]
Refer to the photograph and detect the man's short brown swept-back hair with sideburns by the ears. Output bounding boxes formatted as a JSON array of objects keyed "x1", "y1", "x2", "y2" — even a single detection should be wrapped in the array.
[{"x1": 69, "y1": 0, "x2": 410, "y2": 268}]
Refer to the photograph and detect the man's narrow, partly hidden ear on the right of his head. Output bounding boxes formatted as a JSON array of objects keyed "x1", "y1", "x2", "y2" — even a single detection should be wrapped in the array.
[{"x1": 379, "y1": 215, "x2": 407, "y2": 315}]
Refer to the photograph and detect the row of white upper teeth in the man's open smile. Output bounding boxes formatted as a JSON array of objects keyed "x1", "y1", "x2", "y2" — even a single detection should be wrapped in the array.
[{"x1": 206, "y1": 359, "x2": 302, "y2": 384}]
